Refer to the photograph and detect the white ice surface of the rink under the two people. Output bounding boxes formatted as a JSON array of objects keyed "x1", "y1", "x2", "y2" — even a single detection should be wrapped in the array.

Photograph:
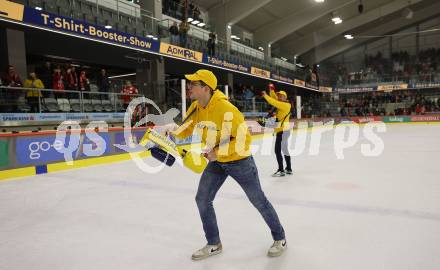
[{"x1": 0, "y1": 124, "x2": 440, "y2": 270}]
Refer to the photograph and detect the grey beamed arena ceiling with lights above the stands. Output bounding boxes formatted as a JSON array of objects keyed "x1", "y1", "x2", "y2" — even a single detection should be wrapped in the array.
[{"x1": 194, "y1": 0, "x2": 440, "y2": 62}]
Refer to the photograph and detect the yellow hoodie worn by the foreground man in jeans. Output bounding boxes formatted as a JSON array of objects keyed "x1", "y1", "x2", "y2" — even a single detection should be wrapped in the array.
[{"x1": 172, "y1": 90, "x2": 251, "y2": 162}]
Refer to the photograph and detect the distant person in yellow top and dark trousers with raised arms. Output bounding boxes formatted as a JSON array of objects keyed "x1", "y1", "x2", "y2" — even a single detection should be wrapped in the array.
[{"x1": 262, "y1": 84, "x2": 292, "y2": 177}]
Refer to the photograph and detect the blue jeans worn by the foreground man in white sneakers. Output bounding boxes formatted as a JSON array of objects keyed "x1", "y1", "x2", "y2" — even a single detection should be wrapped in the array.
[{"x1": 196, "y1": 156, "x2": 285, "y2": 245}]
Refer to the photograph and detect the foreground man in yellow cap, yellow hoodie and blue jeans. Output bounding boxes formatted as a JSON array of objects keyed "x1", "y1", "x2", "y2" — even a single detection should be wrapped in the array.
[{"x1": 169, "y1": 69, "x2": 287, "y2": 260}]
